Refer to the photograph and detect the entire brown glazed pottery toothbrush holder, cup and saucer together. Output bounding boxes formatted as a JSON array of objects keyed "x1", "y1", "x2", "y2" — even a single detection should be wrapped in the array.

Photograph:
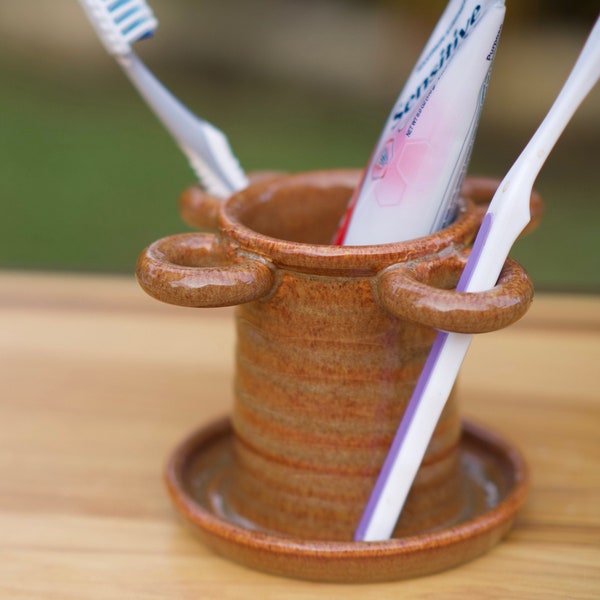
[{"x1": 137, "y1": 170, "x2": 533, "y2": 582}]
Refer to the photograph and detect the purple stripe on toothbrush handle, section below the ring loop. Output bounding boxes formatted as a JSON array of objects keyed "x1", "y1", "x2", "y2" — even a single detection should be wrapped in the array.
[{"x1": 354, "y1": 331, "x2": 448, "y2": 541}]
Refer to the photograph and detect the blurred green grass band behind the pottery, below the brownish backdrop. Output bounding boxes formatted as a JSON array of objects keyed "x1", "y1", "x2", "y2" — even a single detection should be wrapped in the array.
[{"x1": 0, "y1": 59, "x2": 600, "y2": 292}]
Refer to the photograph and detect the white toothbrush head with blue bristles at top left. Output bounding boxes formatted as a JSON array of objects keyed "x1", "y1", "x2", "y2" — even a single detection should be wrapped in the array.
[{"x1": 79, "y1": 0, "x2": 158, "y2": 56}]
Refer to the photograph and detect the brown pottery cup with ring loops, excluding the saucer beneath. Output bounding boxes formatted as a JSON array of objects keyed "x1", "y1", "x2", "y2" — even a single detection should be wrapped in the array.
[{"x1": 137, "y1": 170, "x2": 533, "y2": 540}]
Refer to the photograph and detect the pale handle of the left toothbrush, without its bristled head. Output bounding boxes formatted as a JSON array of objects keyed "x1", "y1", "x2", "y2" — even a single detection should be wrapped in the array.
[{"x1": 115, "y1": 52, "x2": 248, "y2": 198}]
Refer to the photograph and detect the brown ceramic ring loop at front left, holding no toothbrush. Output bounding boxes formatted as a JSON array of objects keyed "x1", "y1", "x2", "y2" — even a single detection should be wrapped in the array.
[{"x1": 136, "y1": 233, "x2": 274, "y2": 308}]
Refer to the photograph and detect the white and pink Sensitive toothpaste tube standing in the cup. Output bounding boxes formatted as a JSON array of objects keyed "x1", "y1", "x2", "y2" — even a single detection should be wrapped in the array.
[{"x1": 334, "y1": 0, "x2": 505, "y2": 245}]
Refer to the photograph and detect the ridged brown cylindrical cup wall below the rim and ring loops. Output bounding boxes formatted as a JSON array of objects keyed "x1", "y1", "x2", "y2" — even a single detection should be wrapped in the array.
[{"x1": 229, "y1": 253, "x2": 462, "y2": 540}]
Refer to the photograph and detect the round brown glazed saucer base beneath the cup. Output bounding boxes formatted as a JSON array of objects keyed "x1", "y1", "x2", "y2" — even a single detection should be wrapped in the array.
[{"x1": 165, "y1": 419, "x2": 528, "y2": 583}]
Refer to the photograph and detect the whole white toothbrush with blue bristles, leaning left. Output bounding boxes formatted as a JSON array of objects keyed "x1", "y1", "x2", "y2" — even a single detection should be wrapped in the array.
[{"x1": 79, "y1": 0, "x2": 248, "y2": 198}]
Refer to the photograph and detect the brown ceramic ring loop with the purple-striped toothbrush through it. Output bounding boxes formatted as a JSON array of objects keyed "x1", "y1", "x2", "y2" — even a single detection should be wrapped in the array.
[{"x1": 376, "y1": 253, "x2": 533, "y2": 334}]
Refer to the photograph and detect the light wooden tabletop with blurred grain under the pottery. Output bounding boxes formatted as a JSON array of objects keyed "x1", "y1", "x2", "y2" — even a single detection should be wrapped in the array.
[{"x1": 0, "y1": 273, "x2": 600, "y2": 600}]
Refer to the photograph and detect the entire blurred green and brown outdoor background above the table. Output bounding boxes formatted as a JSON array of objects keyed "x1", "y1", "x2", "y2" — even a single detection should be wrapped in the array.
[{"x1": 0, "y1": 0, "x2": 600, "y2": 293}]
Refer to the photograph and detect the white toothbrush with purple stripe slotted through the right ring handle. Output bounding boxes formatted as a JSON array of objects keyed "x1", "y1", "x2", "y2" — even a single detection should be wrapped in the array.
[{"x1": 354, "y1": 18, "x2": 600, "y2": 541}]
